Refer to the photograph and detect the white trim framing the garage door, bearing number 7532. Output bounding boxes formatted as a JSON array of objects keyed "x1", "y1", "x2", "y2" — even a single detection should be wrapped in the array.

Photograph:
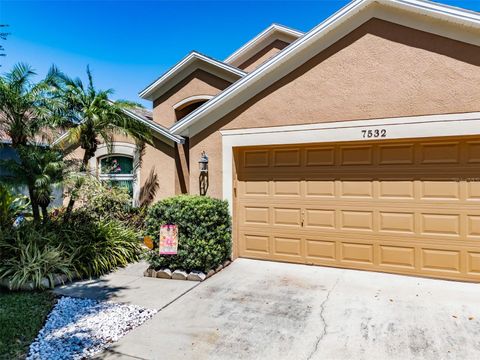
[{"x1": 220, "y1": 112, "x2": 480, "y2": 213}]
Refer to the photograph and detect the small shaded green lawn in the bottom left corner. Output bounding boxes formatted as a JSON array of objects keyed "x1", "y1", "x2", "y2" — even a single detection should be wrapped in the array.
[{"x1": 0, "y1": 290, "x2": 55, "y2": 360}]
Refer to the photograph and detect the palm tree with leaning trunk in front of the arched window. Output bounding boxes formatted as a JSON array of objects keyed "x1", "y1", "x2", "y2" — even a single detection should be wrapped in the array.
[{"x1": 59, "y1": 66, "x2": 151, "y2": 221}]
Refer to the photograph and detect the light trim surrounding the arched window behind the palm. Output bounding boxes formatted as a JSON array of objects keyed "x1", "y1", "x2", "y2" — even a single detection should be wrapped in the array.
[{"x1": 89, "y1": 142, "x2": 141, "y2": 205}]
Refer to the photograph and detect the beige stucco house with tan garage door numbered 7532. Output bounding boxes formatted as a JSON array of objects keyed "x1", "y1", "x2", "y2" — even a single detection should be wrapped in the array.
[{"x1": 71, "y1": 0, "x2": 480, "y2": 281}]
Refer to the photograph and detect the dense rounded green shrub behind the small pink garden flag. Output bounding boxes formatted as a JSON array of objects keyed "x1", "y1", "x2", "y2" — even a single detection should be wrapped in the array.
[{"x1": 145, "y1": 195, "x2": 231, "y2": 272}]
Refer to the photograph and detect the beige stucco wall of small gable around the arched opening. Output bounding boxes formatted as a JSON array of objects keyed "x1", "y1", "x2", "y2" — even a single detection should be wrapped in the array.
[{"x1": 153, "y1": 69, "x2": 230, "y2": 127}]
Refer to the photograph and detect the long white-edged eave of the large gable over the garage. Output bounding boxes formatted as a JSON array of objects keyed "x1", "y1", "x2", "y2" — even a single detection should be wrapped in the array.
[{"x1": 170, "y1": 0, "x2": 480, "y2": 136}]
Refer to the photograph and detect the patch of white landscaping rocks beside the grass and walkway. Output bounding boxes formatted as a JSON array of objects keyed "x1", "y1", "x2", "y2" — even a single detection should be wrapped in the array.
[{"x1": 27, "y1": 297, "x2": 157, "y2": 360}]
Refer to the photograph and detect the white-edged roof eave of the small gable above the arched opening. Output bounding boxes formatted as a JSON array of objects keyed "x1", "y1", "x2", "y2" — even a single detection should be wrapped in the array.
[{"x1": 139, "y1": 51, "x2": 246, "y2": 101}]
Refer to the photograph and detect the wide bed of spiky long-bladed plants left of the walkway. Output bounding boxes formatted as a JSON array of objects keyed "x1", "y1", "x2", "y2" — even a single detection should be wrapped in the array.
[{"x1": 0, "y1": 211, "x2": 142, "y2": 288}]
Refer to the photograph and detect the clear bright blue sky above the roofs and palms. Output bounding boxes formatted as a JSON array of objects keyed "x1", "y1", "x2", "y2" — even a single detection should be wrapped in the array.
[{"x1": 0, "y1": 0, "x2": 480, "y2": 107}]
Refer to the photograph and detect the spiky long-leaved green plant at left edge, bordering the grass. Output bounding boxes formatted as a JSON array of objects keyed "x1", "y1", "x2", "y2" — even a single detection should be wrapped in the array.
[{"x1": 0, "y1": 228, "x2": 73, "y2": 289}]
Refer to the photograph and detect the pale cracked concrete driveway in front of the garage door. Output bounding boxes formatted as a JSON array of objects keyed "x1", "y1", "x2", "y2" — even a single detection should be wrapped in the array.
[{"x1": 100, "y1": 259, "x2": 480, "y2": 360}]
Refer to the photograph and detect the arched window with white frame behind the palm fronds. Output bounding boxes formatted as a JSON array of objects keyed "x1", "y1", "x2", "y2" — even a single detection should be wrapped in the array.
[{"x1": 99, "y1": 155, "x2": 134, "y2": 195}]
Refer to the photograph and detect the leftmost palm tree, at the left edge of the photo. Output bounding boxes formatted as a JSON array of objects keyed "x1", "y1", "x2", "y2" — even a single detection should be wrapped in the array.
[{"x1": 0, "y1": 63, "x2": 62, "y2": 221}]
